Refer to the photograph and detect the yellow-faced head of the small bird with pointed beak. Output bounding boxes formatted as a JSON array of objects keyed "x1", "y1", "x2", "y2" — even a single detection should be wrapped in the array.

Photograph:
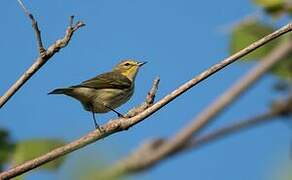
[{"x1": 113, "y1": 60, "x2": 147, "y2": 81}]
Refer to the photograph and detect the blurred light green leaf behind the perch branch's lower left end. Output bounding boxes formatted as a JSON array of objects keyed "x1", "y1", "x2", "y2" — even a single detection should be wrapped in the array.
[{"x1": 12, "y1": 139, "x2": 65, "y2": 170}]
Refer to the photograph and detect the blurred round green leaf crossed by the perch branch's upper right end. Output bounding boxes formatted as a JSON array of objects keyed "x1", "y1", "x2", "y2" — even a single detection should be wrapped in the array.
[{"x1": 230, "y1": 20, "x2": 279, "y2": 60}]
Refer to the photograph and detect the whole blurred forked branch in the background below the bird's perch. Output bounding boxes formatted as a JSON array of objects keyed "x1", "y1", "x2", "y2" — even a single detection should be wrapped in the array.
[{"x1": 94, "y1": 41, "x2": 292, "y2": 179}]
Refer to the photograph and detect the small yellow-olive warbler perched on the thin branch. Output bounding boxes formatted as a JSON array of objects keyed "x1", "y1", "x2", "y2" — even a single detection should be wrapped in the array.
[{"x1": 48, "y1": 60, "x2": 146, "y2": 129}]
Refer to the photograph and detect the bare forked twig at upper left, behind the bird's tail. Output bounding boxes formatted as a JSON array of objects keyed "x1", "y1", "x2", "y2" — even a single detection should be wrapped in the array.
[{"x1": 0, "y1": 0, "x2": 85, "y2": 109}]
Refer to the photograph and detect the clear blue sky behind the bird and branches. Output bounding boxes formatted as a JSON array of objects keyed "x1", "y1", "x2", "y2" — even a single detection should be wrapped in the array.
[{"x1": 0, "y1": 0, "x2": 291, "y2": 180}]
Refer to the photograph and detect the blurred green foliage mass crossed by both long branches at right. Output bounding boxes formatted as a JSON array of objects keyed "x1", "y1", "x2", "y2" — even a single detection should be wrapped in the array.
[{"x1": 229, "y1": 16, "x2": 292, "y2": 80}]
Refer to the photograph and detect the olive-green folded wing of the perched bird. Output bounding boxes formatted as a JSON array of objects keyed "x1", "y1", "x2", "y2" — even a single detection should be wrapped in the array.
[{"x1": 72, "y1": 72, "x2": 132, "y2": 89}]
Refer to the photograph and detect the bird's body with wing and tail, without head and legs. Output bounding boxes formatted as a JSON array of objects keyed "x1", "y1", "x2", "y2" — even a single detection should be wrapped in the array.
[{"x1": 50, "y1": 72, "x2": 134, "y2": 113}]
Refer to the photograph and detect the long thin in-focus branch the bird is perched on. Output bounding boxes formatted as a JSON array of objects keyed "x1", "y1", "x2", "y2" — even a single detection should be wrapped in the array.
[{"x1": 0, "y1": 23, "x2": 292, "y2": 179}]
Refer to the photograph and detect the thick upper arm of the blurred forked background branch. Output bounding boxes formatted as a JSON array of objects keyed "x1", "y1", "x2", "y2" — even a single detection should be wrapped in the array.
[{"x1": 133, "y1": 41, "x2": 292, "y2": 165}]
